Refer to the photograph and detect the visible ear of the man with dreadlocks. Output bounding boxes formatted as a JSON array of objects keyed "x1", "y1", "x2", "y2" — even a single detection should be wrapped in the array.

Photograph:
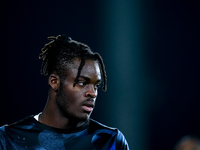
[{"x1": 48, "y1": 74, "x2": 60, "y2": 91}]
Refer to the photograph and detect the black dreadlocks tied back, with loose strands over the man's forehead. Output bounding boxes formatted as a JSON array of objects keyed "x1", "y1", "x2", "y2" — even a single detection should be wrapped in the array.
[{"x1": 39, "y1": 35, "x2": 107, "y2": 91}]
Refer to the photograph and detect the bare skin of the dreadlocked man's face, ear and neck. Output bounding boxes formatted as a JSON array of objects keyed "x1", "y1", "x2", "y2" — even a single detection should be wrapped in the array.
[{"x1": 39, "y1": 58, "x2": 101, "y2": 129}]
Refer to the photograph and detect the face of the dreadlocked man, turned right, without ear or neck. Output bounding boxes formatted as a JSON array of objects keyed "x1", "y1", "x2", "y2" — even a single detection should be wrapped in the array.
[{"x1": 56, "y1": 59, "x2": 101, "y2": 121}]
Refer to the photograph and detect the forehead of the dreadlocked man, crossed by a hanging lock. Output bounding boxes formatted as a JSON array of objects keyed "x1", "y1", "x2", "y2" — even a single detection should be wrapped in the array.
[{"x1": 68, "y1": 58, "x2": 101, "y2": 80}]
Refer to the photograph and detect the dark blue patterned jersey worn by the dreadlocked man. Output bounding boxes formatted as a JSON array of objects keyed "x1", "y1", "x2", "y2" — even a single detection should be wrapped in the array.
[{"x1": 0, "y1": 116, "x2": 129, "y2": 150}]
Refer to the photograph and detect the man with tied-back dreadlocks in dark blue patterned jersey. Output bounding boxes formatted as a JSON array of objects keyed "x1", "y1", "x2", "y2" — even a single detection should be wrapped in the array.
[{"x1": 0, "y1": 35, "x2": 129, "y2": 150}]
